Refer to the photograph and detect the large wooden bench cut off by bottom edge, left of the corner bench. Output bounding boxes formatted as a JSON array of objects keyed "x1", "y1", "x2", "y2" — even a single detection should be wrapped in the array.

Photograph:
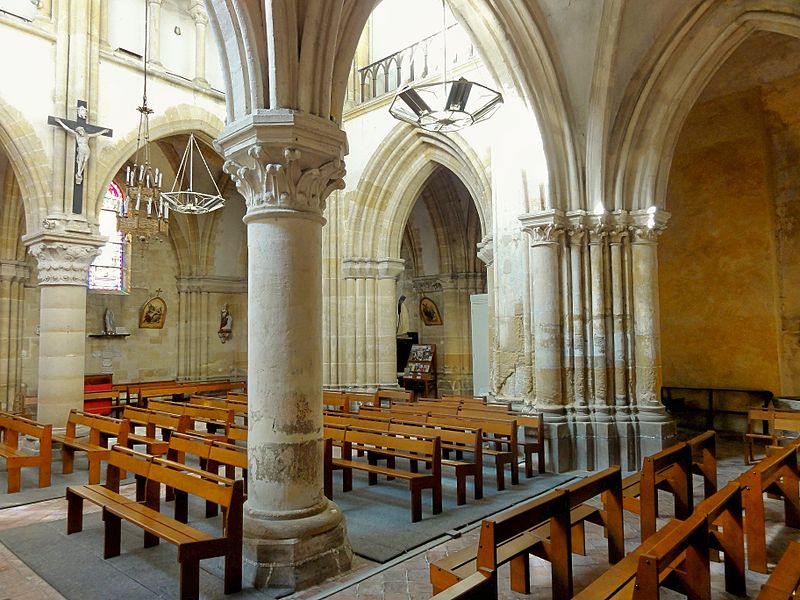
[{"x1": 575, "y1": 482, "x2": 746, "y2": 600}]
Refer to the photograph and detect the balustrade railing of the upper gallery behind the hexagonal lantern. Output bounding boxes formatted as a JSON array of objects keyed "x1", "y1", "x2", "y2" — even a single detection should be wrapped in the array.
[{"x1": 355, "y1": 25, "x2": 475, "y2": 104}]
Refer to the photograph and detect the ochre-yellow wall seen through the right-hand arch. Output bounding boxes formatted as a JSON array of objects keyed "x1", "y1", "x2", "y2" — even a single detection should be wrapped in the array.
[{"x1": 659, "y1": 88, "x2": 798, "y2": 393}]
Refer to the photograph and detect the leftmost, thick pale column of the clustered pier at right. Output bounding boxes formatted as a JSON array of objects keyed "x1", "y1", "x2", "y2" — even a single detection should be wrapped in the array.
[{"x1": 520, "y1": 209, "x2": 573, "y2": 472}]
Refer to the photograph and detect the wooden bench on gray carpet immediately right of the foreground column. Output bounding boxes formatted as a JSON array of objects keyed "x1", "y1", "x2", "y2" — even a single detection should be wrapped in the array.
[{"x1": 325, "y1": 428, "x2": 442, "y2": 523}]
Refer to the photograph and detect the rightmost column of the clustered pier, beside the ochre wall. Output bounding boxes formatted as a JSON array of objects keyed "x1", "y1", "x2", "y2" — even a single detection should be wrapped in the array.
[{"x1": 631, "y1": 208, "x2": 676, "y2": 456}]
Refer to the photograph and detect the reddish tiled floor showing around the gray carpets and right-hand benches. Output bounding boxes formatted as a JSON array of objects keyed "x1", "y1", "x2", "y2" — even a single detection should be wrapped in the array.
[{"x1": 0, "y1": 439, "x2": 800, "y2": 600}]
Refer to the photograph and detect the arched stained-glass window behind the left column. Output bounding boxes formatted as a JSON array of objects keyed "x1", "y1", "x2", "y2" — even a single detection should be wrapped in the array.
[{"x1": 89, "y1": 181, "x2": 128, "y2": 292}]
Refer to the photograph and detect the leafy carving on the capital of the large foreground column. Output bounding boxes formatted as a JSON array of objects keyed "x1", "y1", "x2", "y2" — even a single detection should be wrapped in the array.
[{"x1": 223, "y1": 144, "x2": 345, "y2": 214}]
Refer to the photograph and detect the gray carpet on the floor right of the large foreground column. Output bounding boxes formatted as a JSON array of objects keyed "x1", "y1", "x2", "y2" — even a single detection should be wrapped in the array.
[{"x1": 333, "y1": 469, "x2": 575, "y2": 563}]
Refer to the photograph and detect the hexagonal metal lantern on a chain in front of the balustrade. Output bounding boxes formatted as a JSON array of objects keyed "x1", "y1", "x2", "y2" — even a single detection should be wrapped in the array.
[{"x1": 389, "y1": 0, "x2": 503, "y2": 133}]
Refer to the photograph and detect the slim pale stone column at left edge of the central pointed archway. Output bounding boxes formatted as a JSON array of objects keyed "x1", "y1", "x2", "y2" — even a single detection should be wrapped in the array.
[{"x1": 377, "y1": 258, "x2": 405, "y2": 388}]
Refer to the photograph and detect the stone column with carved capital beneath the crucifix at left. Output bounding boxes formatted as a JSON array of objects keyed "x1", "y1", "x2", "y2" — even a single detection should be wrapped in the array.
[{"x1": 28, "y1": 236, "x2": 102, "y2": 429}]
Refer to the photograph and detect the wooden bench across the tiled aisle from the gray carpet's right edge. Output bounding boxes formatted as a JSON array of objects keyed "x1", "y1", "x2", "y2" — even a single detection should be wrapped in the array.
[{"x1": 430, "y1": 467, "x2": 625, "y2": 598}]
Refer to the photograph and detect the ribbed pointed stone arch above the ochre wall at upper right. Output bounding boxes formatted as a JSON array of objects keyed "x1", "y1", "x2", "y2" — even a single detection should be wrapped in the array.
[{"x1": 611, "y1": 0, "x2": 800, "y2": 210}]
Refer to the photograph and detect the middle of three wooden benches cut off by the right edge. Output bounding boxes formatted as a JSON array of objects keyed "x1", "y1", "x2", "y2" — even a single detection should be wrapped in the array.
[{"x1": 737, "y1": 440, "x2": 800, "y2": 573}]
